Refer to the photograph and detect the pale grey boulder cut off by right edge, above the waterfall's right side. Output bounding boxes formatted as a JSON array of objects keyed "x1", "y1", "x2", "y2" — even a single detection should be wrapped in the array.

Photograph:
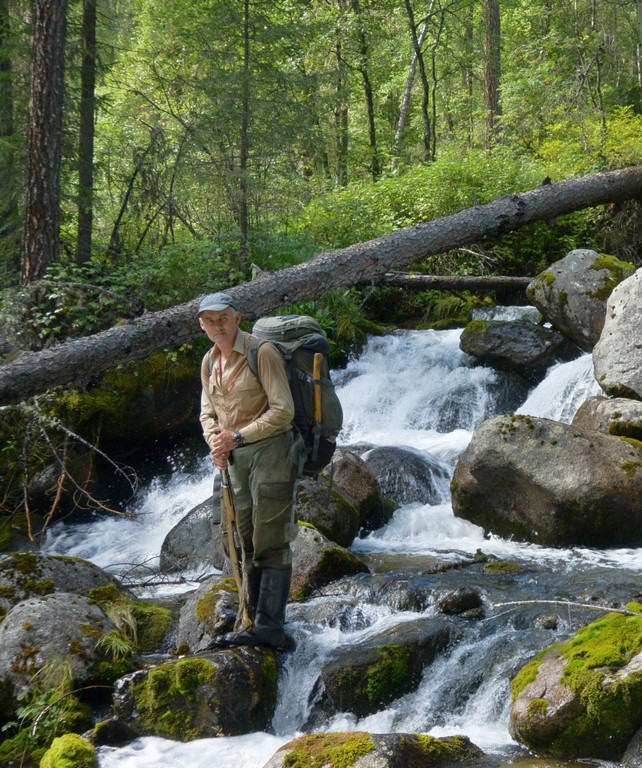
[{"x1": 593, "y1": 269, "x2": 642, "y2": 400}]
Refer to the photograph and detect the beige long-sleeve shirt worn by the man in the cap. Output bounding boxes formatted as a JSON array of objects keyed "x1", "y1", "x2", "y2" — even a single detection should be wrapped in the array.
[{"x1": 200, "y1": 330, "x2": 294, "y2": 447}]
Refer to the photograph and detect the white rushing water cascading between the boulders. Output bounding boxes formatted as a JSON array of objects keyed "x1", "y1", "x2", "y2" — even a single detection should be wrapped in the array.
[{"x1": 43, "y1": 330, "x2": 642, "y2": 768}]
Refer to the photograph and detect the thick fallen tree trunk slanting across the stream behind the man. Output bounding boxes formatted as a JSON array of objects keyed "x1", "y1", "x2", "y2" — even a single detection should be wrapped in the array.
[{"x1": 0, "y1": 167, "x2": 642, "y2": 404}]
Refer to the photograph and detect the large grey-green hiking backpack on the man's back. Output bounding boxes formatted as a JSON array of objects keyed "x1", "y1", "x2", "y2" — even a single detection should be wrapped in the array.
[{"x1": 248, "y1": 315, "x2": 343, "y2": 477}]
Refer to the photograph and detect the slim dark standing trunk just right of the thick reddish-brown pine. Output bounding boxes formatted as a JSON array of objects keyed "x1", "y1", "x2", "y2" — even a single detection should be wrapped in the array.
[{"x1": 76, "y1": 0, "x2": 96, "y2": 264}]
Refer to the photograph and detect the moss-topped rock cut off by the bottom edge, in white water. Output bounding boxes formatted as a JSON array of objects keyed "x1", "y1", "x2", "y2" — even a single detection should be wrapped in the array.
[{"x1": 264, "y1": 731, "x2": 493, "y2": 768}]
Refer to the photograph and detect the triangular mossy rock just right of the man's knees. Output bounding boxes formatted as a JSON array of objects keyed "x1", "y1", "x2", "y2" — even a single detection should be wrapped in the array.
[{"x1": 290, "y1": 524, "x2": 368, "y2": 600}]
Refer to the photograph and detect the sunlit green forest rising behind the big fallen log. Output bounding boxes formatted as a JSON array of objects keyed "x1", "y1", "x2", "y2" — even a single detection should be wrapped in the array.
[{"x1": 0, "y1": 0, "x2": 642, "y2": 308}]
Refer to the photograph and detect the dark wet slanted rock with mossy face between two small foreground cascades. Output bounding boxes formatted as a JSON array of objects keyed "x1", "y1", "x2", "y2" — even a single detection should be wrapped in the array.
[{"x1": 321, "y1": 618, "x2": 458, "y2": 717}]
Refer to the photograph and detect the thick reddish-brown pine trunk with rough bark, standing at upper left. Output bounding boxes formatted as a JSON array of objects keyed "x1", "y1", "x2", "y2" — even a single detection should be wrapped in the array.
[{"x1": 22, "y1": 0, "x2": 67, "y2": 285}]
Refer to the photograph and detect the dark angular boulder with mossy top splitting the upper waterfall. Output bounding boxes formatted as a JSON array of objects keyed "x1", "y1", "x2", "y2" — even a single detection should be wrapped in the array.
[{"x1": 459, "y1": 320, "x2": 581, "y2": 382}]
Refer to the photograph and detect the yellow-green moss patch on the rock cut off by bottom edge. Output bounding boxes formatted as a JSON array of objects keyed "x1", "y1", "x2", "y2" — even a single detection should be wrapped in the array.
[{"x1": 283, "y1": 731, "x2": 376, "y2": 768}]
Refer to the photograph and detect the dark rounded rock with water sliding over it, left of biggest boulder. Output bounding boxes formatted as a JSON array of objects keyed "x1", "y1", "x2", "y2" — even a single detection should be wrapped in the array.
[{"x1": 363, "y1": 446, "x2": 449, "y2": 505}]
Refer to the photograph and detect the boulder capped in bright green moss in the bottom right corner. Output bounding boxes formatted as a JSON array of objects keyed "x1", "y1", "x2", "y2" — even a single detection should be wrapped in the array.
[{"x1": 510, "y1": 606, "x2": 642, "y2": 761}]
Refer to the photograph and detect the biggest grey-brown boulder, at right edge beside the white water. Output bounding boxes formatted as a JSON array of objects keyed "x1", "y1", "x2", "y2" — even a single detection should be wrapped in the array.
[{"x1": 451, "y1": 415, "x2": 642, "y2": 547}]
